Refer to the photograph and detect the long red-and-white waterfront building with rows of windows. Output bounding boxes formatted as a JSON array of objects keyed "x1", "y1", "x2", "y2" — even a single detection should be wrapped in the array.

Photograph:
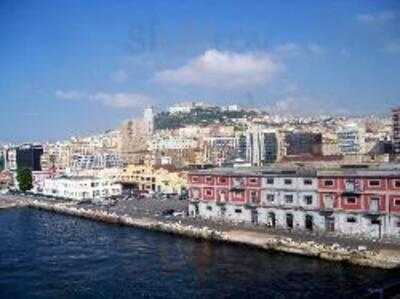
[{"x1": 188, "y1": 167, "x2": 400, "y2": 238}]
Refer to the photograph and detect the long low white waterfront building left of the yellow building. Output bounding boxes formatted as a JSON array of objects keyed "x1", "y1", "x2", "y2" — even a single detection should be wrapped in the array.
[{"x1": 39, "y1": 176, "x2": 122, "y2": 200}]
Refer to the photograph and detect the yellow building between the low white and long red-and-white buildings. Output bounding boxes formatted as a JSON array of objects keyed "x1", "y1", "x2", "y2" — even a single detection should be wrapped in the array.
[{"x1": 120, "y1": 164, "x2": 187, "y2": 194}]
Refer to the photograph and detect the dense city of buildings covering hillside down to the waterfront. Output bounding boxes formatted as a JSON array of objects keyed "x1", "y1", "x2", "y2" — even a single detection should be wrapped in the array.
[{"x1": 1, "y1": 102, "x2": 400, "y2": 239}]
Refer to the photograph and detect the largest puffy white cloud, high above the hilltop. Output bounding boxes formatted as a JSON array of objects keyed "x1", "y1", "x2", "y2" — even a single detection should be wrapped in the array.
[{"x1": 155, "y1": 50, "x2": 283, "y2": 88}]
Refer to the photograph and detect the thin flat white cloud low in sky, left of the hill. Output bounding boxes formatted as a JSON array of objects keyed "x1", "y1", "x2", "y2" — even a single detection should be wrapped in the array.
[{"x1": 55, "y1": 90, "x2": 153, "y2": 108}]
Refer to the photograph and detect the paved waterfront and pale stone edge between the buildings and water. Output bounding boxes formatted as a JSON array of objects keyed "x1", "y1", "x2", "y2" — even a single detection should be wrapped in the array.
[{"x1": 0, "y1": 195, "x2": 400, "y2": 269}]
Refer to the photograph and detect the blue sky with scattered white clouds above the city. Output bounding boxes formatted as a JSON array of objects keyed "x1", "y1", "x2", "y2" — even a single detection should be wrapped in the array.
[{"x1": 0, "y1": 0, "x2": 400, "y2": 142}]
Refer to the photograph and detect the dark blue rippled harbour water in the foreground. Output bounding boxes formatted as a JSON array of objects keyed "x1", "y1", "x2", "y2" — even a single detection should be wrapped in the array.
[{"x1": 0, "y1": 209, "x2": 398, "y2": 298}]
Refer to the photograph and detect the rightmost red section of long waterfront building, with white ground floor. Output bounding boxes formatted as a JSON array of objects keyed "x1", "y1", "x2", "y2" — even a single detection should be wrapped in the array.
[{"x1": 318, "y1": 169, "x2": 400, "y2": 238}]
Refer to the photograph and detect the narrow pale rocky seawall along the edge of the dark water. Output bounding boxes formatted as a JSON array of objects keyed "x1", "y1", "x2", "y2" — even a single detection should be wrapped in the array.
[{"x1": 24, "y1": 200, "x2": 400, "y2": 269}]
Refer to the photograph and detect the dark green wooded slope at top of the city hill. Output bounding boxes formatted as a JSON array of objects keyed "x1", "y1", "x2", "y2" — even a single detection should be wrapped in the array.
[{"x1": 154, "y1": 107, "x2": 258, "y2": 130}]
